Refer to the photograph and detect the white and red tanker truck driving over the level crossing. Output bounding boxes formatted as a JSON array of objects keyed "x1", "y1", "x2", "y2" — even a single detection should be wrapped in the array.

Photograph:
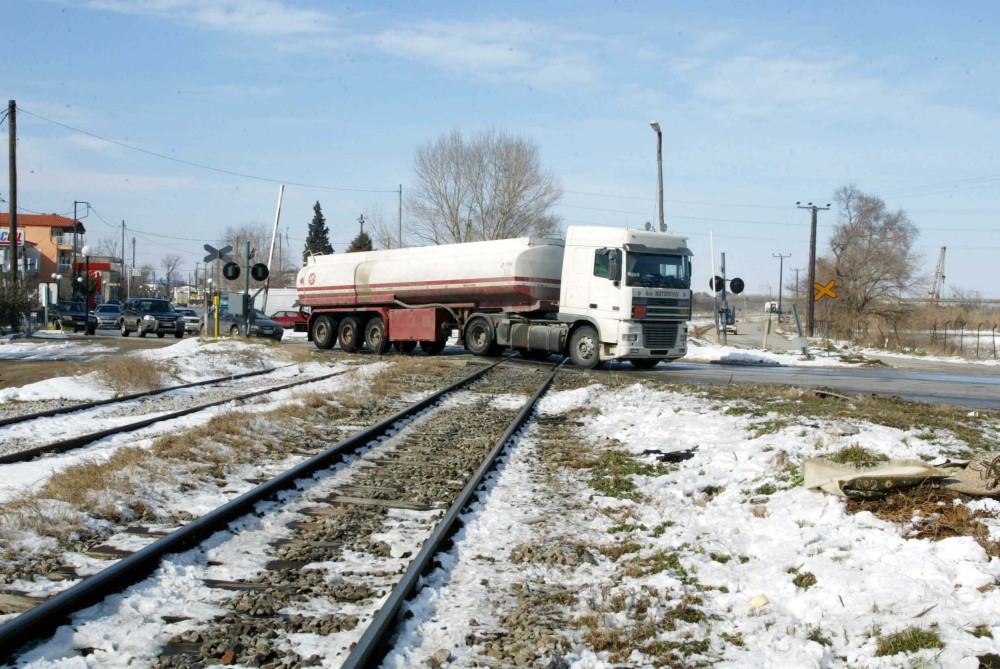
[{"x1": 296, "y1": 226, "x2": 692, "y2": 369}]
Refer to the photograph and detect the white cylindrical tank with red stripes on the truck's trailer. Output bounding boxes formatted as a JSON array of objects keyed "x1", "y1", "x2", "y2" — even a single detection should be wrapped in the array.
[{"x1": 296, "y1": 237, "x2": 563, "y2": 311}]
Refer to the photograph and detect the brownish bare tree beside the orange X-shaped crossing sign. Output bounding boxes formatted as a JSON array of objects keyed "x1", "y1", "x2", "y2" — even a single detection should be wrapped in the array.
[{"x1": 823, "y1": 184, "x2": 924, "y2": 338}]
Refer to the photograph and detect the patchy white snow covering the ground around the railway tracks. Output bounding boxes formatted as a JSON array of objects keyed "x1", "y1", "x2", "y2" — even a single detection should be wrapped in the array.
[{"x1": 0, "y1": 339, "x2": 1000, "y2": 669}]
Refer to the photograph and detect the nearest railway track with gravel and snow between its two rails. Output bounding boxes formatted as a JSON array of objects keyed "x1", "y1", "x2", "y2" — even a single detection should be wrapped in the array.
[{"x1": 0, "y1": 361, "x2": 555, "y2": 668}]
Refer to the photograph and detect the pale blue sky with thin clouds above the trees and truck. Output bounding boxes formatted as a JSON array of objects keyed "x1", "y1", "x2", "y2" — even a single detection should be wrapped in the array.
[{"x1": 0, "y1": 0, "x2": 1000, "y2": 298}]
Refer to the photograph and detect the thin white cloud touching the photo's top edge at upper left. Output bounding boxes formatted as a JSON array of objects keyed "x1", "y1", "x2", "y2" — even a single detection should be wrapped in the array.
[{"x1": 87, "y1": 0, "x2": 333, "y2": 35}]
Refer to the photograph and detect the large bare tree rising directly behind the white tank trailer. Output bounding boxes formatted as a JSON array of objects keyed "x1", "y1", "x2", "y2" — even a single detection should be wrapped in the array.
[{"x1": 408, "y1": 129, "x2": 562, "y2": 244}]
